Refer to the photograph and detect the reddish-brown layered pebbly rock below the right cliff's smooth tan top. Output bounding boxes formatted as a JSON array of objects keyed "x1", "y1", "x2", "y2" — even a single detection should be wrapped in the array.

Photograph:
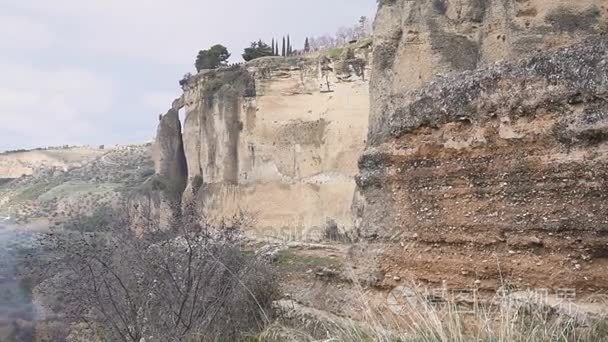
[{"x1": 359, "y1": 38, "x2": 608, "y2": 235}]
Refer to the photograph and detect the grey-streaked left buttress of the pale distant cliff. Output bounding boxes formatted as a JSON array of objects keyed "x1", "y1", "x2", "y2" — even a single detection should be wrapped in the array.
[{"x1": 184, "y1": 66, "x2": 256, "y2": 185}]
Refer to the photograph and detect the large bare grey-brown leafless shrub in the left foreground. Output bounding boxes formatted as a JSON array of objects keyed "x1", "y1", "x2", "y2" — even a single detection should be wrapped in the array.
[{"x1": 26, "y1": 204, "x2": 276, "y2": 342}]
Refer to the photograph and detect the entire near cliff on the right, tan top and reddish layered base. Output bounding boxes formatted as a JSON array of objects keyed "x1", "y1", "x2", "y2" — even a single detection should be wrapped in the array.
[{"x1": 354, "y1": 0, "x2": 608, "y2": 290}]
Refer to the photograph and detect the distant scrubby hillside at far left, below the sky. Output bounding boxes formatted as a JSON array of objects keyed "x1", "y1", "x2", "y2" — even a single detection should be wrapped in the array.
[{"x1": 0, "y1": 145, "x2": 154, "y2": 225}]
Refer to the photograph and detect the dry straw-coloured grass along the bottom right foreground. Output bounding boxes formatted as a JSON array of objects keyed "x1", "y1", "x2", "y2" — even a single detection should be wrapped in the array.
[{"x1": 259, "y1": 270, "x2": 608, "y2": 342}]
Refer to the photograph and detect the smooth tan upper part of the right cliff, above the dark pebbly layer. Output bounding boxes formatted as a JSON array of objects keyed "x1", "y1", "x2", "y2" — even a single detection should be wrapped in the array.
[{"x1": 369, "y1": 0, "x2": 608, "y2": 142}]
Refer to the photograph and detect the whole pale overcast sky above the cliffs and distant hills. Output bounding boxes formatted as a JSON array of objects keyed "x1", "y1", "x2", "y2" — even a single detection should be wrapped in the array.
[{"x1": 0, "y1": 0, "x2": 376, "y2": 150}]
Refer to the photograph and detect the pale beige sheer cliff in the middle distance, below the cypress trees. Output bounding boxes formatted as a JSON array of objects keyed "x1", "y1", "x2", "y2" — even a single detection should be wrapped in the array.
[{"x1": 183, "y1": 48, "x2": 369, "y2": 238}]
